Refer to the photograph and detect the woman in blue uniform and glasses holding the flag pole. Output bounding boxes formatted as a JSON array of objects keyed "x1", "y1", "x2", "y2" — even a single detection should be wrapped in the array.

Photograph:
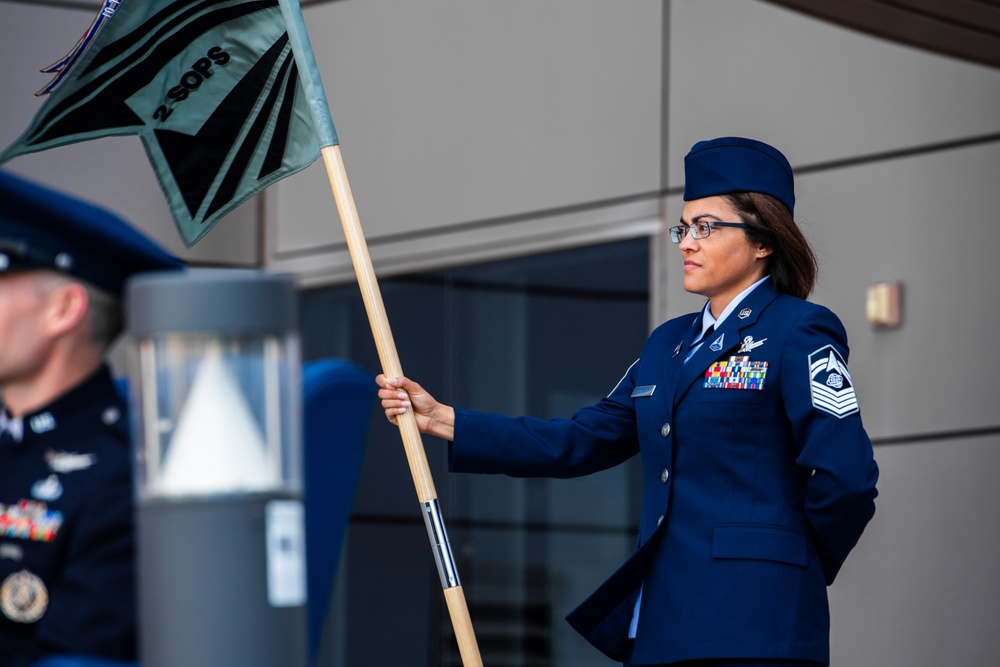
[{"x1": 377, "y1": 137, "x2": 878, "y2": 667}]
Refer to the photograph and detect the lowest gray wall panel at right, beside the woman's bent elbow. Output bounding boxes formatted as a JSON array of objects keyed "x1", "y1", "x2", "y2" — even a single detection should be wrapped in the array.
[{"x1": 829, "y1": 435, "x2": 1000, "y2": 667}]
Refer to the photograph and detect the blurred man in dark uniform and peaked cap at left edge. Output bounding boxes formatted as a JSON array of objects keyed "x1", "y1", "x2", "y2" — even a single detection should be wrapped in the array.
[{"x1": 0, "y1": 172, "x2": 180, "y2": 667}]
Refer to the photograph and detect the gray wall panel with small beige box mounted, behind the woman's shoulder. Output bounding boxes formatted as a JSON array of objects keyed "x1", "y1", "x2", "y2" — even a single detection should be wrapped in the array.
[{"x1": 800, "y1": 142, "x2": 1000, "y2": 437}]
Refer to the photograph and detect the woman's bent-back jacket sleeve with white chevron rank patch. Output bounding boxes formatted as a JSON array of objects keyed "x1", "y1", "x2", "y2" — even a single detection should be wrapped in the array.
[{"x1": 782, "y1": 307, "x2": 878, "y2": 585}]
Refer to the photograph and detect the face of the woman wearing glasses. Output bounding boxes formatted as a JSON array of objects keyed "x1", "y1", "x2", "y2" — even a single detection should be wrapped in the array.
[{"x1": 678, "y1": 197, "x2": 771, "y2": 317}]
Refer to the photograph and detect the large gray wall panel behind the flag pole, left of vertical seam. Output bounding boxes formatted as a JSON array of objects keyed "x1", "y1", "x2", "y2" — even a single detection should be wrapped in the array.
[{"x1": 267, "y1": 0, "x2": 662, "y2": 280}]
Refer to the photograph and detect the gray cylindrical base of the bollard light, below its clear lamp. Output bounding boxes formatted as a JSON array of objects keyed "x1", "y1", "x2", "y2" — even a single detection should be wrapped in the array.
[{"x1": 137, "y1": 494, "x2": 306, "y2": 667}]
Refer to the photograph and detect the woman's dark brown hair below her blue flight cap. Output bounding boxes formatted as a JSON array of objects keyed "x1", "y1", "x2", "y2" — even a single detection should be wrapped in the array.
[{"x1": 724, "y1": 192, "x2": 817, "y2": 299}]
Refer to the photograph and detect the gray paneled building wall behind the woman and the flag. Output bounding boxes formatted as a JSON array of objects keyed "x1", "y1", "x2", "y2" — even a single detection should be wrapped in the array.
[{"x1": 0, "y1": 0, "x2": 1000, "y2": 667}]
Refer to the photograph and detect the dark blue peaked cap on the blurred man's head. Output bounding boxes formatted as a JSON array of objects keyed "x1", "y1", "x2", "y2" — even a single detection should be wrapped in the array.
[{"x1": 0, "y1": 170, "x2": 183, "y2": 296}]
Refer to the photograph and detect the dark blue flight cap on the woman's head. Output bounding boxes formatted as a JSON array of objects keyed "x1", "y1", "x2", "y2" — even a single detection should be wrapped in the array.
[{"x1": 684, "y1": 137, "x2": 795, "y2": 212}]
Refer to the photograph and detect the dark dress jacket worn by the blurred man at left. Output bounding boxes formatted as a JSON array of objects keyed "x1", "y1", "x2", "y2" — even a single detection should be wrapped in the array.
[{"x1": 0, "y1": 367, "x2": 136, "y2": 667}]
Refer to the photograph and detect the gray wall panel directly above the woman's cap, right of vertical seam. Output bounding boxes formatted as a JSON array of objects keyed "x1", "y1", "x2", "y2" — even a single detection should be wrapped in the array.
[{"x1": 667, "y1": 0, "x2": 1000, "y2": 186}]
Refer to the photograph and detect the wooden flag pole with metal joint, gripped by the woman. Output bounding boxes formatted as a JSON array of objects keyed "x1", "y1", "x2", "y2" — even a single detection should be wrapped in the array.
[{"x1": 278, "y1": 0, "x2": 483, "y2": 667}]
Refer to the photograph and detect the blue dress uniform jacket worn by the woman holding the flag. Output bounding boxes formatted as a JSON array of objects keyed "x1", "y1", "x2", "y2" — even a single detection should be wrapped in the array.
[{"x1": 450, "y1": 280, "x2": 878, "y2": 664}]
